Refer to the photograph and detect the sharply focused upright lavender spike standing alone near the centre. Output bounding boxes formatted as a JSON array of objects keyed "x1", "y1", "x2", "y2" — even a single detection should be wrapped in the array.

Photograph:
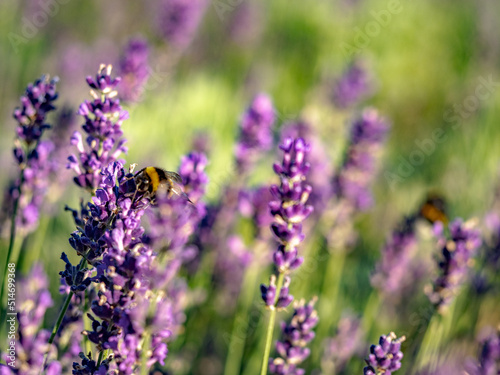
[{"x1": 261, "y1": 138, "x2": 313, "y2": 308}]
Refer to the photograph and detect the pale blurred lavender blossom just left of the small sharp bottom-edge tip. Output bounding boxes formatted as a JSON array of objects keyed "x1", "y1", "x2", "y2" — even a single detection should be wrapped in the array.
[{"x1": 321, "y1": 315, "x2": 364, "y2": 373}]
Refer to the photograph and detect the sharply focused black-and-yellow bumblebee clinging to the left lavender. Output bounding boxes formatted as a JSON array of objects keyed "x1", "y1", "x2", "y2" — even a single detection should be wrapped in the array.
[{"x1": 134, "y1": 167, "x2": 191, "y2": 202}]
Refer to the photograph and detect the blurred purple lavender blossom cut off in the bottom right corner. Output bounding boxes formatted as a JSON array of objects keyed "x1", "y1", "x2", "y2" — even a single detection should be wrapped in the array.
[{"x1": 467, "y1": 330, "x2": 500, "y2": 375}]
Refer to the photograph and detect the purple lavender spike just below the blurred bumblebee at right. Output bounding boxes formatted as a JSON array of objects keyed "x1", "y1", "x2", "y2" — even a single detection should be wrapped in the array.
[{"x1": 426, "y1": 219, "x2": 481, "y2": 311}]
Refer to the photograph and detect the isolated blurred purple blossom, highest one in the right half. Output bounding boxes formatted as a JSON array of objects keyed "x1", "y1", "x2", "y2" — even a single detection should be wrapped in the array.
[{"x1": 332, "y1": 62, "x2": 372, "y2": 109}]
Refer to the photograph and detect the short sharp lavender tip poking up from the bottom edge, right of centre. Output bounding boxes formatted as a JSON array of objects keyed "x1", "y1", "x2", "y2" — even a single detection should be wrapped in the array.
[{"x1": 363, "y1": 332, "x2": 405, "y2": 375}]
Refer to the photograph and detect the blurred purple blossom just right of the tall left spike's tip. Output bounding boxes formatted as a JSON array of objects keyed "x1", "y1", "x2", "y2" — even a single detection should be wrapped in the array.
[{"x1": 120, "y1": 38, "x2": 149, "y2": 103}]
